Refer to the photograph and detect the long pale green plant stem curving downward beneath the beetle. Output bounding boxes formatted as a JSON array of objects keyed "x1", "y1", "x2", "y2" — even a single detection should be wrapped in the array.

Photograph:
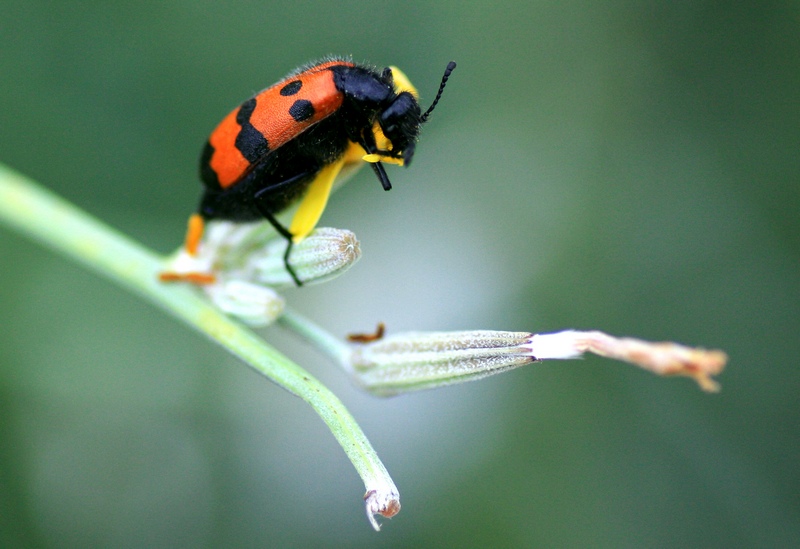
[{"x1": 0, "y1": 164, "x2": 396, "y2": 520}]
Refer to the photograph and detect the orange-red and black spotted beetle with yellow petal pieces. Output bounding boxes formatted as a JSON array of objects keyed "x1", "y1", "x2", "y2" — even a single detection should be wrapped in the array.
[{"x1": 174, "y1": 57, "x2": 456, "y2": 286}]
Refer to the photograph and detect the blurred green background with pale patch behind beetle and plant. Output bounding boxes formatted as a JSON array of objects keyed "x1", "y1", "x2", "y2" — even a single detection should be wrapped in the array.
[{"x1": 0, "y1": 0, "x2": 800, "y2": 547}]
